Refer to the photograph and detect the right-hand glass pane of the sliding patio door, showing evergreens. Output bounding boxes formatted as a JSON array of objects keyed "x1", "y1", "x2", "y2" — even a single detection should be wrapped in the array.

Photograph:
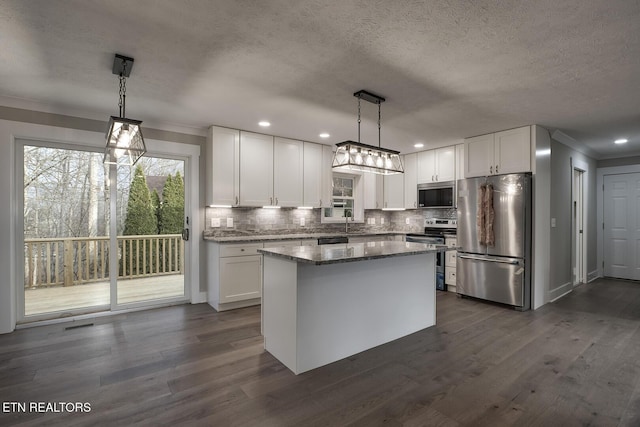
[{"x1": 115, "y1": 156, "x2": 185, "y2": 305}]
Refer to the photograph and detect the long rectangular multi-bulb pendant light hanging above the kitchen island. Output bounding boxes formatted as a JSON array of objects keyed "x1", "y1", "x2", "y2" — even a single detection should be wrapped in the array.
[{"x1": 332, "y1": 90, "x2": 404, "y2": 175}]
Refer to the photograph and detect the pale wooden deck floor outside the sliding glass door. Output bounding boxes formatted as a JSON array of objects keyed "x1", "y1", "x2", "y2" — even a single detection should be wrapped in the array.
[{"x1": 25, "y1": 274, "x2": 184, "y2": 316}]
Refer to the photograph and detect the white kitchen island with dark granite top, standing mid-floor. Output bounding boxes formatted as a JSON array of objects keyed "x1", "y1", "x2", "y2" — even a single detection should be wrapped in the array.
[{"x1": 258, "y1": 241, "x2": 454, "y2": 374}]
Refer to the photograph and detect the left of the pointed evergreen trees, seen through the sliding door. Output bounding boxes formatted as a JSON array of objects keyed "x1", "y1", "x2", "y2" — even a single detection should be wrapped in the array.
[{"x1": 123, "y1": 166, "x2": 158, "y2": 236}]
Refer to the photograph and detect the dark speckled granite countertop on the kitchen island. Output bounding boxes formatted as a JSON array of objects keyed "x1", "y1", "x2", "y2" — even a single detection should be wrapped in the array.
[{"x1": 258, "y1": 241, "x2": 456, "y2": 265}]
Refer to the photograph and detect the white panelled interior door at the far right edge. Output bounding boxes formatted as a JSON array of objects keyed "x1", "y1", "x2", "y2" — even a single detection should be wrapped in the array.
[{"x1": 604, "y1": 173, "x2": 640, "y2": 280}]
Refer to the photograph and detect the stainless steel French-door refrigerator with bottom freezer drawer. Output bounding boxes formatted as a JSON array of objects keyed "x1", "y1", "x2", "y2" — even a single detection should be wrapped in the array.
[{"x1": 456, "y1": 174, "x2": 531, "y2": 310}]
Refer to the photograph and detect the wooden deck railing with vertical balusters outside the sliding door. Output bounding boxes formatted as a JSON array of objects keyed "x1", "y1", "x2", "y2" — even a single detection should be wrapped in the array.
[{"x1": 24, "y1": 234, "x2": 184, "y2": 288}]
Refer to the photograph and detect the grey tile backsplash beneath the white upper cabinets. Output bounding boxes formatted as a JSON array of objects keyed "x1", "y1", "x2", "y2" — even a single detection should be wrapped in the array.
[{"x1": 205, "y1": 207, "x2": 456, "y2": 235}]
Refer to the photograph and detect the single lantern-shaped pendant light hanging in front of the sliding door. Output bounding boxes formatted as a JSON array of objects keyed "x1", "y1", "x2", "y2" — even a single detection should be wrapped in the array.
[{"x1": 104, "y1": 53, "x2": 147, "y2": 165}]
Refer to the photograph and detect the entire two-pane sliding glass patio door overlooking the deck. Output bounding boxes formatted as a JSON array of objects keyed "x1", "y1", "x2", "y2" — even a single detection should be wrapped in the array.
[{"x1": 18, "y1": 141, "x2": 188, "y2": 320}]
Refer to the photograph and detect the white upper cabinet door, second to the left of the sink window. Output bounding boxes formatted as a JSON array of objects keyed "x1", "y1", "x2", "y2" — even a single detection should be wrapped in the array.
[{"x1": 272, "y1": 137, "x2": 304, "y2": 208}]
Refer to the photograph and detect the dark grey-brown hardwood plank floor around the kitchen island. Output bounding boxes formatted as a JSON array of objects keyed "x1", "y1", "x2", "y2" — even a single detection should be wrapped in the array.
[{"x1": 0, "y1": 280, "x2": 640, "y2": 427}]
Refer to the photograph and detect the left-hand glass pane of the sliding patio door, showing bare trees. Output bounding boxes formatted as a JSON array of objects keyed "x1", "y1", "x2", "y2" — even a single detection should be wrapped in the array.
[{"x1": 23, "y1": 145, "x2": 110, "y2": 316}]
